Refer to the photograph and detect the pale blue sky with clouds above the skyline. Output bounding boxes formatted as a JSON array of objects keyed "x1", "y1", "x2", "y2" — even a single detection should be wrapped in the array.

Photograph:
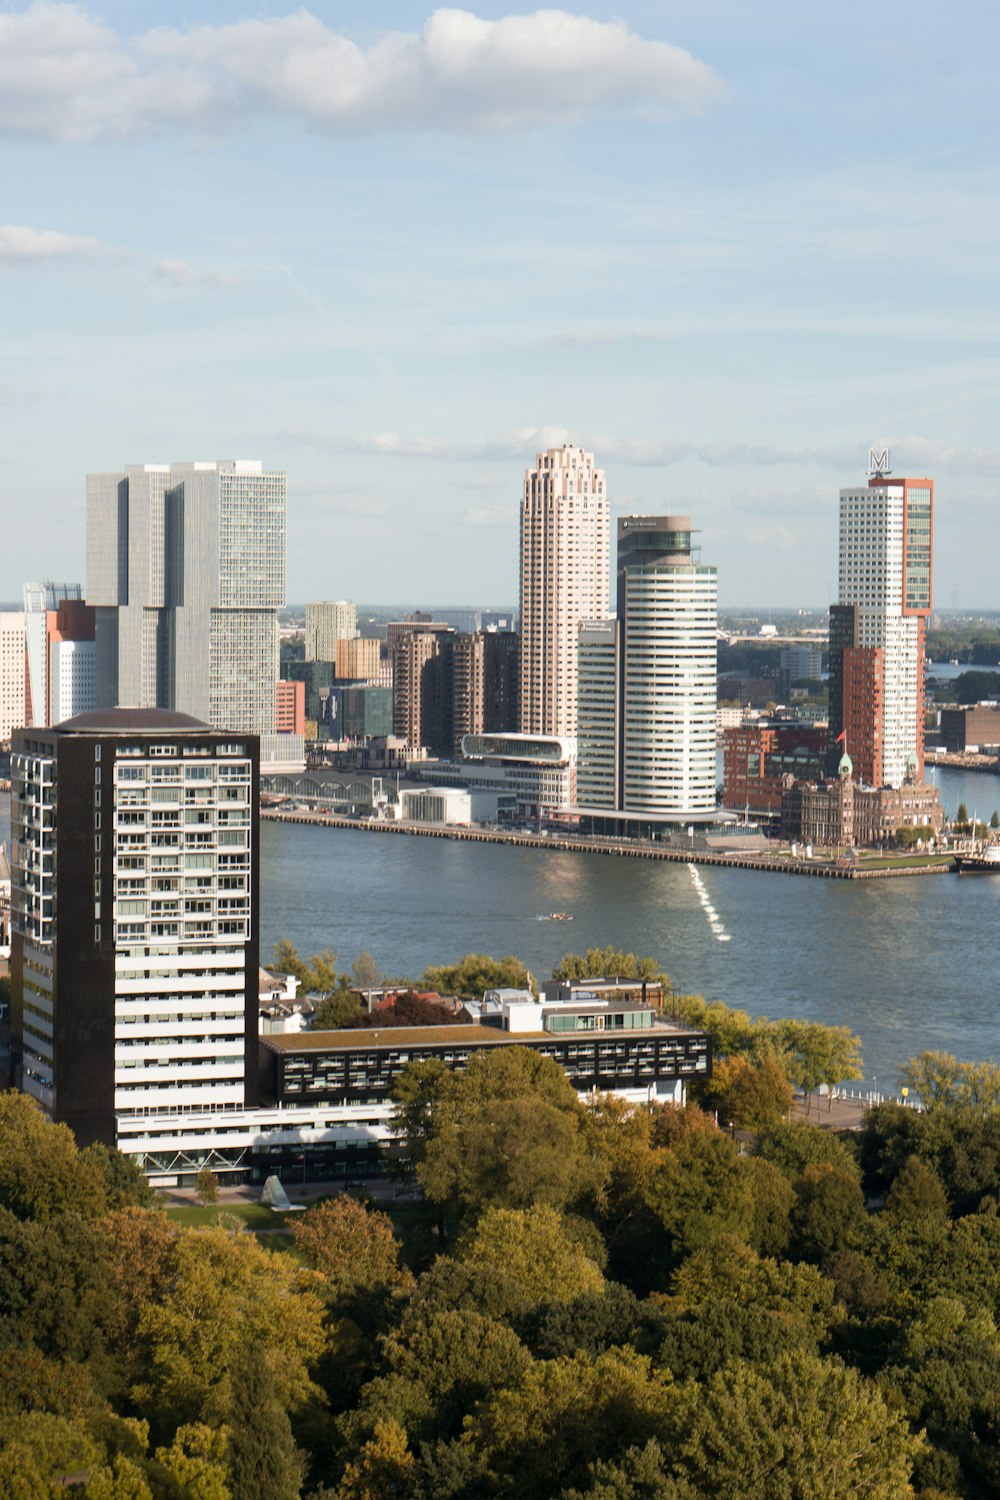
[{"x1": 0, "y1": 0, "x2": 1000, "y2": 609}]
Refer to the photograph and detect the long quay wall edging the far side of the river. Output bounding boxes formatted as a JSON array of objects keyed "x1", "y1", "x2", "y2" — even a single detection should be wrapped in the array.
[{"x1": 261, "y1": 807, "x2": 955, "y2": 881}]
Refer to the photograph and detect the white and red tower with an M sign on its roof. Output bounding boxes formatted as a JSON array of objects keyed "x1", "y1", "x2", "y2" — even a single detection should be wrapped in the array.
[{"x1": 829, "y1": 452, "x2": 934, "y2": 788}]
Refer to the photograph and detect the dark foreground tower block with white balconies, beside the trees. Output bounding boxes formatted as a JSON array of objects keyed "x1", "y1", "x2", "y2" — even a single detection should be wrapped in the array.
[{"x1": 10, "y1": 708, "x2": 258, "y2": 1146}]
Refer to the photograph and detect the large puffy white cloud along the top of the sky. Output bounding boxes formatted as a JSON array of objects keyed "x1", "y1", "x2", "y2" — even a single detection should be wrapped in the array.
[{"x1": 0, "y1": 0, "x2": 724, "y2": 141}]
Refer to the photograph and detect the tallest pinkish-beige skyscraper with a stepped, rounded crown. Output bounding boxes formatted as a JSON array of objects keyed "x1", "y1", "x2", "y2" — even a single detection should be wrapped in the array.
[{"x1": 519, "y1": 444, "x2": 612, "y2": 735}]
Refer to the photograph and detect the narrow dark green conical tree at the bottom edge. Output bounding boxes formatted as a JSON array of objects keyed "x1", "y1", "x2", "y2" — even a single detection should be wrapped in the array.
[{"x1": 229, "y1": 1344, "x2": 303, "y2": 1500}]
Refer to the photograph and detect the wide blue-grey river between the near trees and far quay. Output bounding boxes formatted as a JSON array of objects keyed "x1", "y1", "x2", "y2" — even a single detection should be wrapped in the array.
[{"x1": 0, "y1": 768, "x2": 1000, "y2": 1089}]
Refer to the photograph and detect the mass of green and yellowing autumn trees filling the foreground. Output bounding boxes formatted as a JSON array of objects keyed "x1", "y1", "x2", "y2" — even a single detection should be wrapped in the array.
[{"x1": 9, "y1": 1038, "x2": 1000, "y2": 1500}]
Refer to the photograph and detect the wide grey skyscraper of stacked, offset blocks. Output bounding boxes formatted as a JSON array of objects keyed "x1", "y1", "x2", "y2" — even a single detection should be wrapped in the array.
[{"x1": 87, "y1": 461, "x2": 285, "y2": 750}]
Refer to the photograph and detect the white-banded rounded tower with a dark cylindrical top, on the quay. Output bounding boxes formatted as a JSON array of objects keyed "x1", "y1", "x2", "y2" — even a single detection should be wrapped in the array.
[{"x1": 577, "y1": 516, "x2": 717, "y2": 822}]
